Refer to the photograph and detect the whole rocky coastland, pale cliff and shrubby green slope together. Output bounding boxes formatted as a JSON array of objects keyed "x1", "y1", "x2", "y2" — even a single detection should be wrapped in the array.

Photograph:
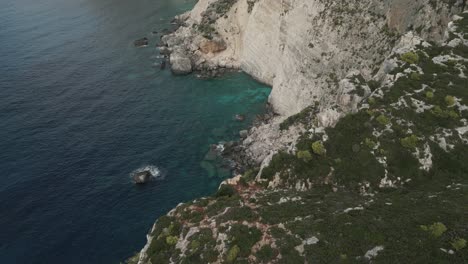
[{"x1": 128, "y1": 0, "x2": 468, "y2": 264}]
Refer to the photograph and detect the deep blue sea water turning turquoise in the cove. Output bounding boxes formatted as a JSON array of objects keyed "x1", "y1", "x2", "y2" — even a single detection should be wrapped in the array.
[{"x1": 0, "y1": 0, "x2": 269, "y2": 263}]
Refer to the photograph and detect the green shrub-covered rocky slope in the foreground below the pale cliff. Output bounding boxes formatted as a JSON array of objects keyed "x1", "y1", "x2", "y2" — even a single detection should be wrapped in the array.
[{"x1": 129, "y1": 12, "x2": 468, "y2": 264}]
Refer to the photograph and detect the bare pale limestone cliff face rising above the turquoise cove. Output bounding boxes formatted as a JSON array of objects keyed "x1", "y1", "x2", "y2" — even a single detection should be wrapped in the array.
[{"x1": 166, "y1": 0, "x2": 461, "y2": 116}]
